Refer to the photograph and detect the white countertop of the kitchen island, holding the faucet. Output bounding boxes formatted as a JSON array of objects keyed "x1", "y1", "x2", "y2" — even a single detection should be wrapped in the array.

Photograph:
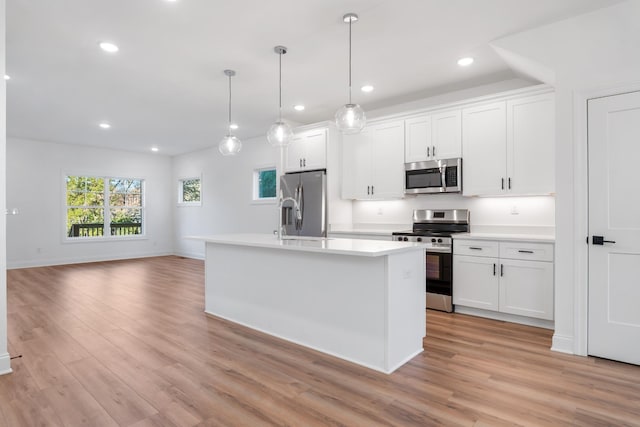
[{"x1": 188, "y1": 234, "x2": 424, "y2": 257}]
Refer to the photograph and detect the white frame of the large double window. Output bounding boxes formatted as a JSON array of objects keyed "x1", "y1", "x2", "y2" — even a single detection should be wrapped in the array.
[{"x1": 61, "y1": 172, "x2": 148, "y2": 243}]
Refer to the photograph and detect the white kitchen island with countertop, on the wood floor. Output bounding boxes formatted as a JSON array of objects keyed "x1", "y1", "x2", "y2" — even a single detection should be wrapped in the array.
[{"x1": 195, "y1": 234, "x2": 426, "y2": 373}]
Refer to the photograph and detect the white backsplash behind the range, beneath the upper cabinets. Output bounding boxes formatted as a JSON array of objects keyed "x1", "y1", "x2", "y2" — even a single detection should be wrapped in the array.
[{"x1": 353, "y1": 194, "x2": 555, "y2": 234}]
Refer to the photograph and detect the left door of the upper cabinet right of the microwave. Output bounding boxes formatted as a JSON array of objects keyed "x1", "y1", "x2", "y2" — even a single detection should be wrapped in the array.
[{"x1": 462, "y1": 101, "x2": 507, "y2": 196}]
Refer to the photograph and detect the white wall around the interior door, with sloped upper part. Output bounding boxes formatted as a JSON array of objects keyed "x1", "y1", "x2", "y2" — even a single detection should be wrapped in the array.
[{"x1": 495, "y1": 0, "x2": 640, "y2": 354}]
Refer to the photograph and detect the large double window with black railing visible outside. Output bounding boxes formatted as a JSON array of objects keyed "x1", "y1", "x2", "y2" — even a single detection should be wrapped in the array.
[{"x1": 65, "y1": 175, "x2": 144, "y2": 239}]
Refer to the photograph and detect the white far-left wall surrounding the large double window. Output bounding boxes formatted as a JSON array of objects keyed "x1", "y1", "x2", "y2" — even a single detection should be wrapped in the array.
[{"x1": 7, "y1": 138, "x2": 173, "y2": 268}]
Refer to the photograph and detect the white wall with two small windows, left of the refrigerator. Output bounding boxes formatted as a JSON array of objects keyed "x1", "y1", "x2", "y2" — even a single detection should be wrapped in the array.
[{"x1": 170, "y1": 136, "x2": 280, "y2": 258}]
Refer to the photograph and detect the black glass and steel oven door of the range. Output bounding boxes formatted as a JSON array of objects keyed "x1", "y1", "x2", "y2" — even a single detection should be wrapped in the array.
[{"x1": 426, "y1": 249, "x2": 453, "y2": 312}]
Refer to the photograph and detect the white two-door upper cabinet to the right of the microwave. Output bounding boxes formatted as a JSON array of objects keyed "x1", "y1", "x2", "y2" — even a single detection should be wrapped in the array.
[{"x1": 462, "y1": 93, "x2": 555, "y2": 196}]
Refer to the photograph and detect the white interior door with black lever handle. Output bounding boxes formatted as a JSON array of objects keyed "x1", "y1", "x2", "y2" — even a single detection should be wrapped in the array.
[{"x1": 588, "y1": 92, "x2": 640, "y2": 365}]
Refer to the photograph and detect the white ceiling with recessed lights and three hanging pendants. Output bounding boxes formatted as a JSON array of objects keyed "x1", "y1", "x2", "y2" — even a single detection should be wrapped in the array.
[{"x1": 7, "y1": 0, "x2": 619, "y2": 155}]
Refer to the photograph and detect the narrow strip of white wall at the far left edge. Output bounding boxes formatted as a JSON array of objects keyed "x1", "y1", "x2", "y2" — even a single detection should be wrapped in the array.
[{"x1": 0, "y1": 0, "x2": 11, "y2": 374}]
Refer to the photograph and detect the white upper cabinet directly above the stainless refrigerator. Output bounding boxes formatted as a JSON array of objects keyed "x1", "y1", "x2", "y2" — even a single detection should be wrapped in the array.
[{"x1": 284, "y1": 128, "x2": 327, "y2": 172}]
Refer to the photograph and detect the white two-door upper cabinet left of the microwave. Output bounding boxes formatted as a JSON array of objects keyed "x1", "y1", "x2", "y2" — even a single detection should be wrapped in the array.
[{"x1": 342, "y1": 120, "x2": 404, "y2": 200}]
